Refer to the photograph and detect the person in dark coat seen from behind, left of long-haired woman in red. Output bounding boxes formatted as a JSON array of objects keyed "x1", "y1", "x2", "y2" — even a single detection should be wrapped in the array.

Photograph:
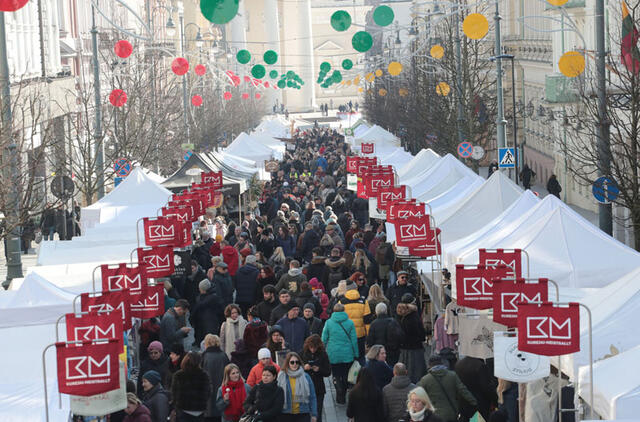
[{"x1": 171, "y1": 352, "x2": 211, "y2": 422}]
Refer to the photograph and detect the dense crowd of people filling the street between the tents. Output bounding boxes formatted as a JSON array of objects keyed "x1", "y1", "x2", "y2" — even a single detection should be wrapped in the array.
[{"x1": 111, "y1": 129, "x2": 517, "y2": 422}]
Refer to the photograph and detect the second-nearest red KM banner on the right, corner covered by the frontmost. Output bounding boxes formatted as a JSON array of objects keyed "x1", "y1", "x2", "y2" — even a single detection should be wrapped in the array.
[{"x1": 493, "y1": 278, "x2": 549, "y2": 328}]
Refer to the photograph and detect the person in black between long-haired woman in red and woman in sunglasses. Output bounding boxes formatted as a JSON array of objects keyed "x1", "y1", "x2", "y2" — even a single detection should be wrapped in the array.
[{"x1": 243, "y1": 365, "x2": 284, "y2": 422}]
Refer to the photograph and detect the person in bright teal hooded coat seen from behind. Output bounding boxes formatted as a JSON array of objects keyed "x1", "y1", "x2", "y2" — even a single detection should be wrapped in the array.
[{"x1": 322, "y1": 303, "x2": 358, "y2": 404}]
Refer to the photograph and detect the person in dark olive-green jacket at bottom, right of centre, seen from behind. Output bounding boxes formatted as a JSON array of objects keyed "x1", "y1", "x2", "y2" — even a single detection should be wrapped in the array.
[{"x1": 418, "y1": 355, "x2": 478, "y2": 422}]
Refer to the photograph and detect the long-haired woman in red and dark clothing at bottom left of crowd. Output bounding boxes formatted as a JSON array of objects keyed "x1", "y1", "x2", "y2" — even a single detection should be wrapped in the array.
[{"x1": 216, "y1": 363, "x2": 251, "y2": 422}]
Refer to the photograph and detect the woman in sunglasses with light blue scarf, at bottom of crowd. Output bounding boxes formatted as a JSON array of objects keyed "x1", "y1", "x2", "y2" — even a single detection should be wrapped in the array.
[{"x1": 278, "y1": 352, "x2": 318, "y2": 422}]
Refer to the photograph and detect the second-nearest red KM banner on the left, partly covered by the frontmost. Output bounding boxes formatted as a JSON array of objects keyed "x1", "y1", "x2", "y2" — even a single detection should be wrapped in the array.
[{"x1": 64, "y1": 312, "x2": 124, "y2": 353}]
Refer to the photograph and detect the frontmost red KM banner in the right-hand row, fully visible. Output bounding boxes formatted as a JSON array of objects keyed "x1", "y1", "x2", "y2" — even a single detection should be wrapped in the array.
[{"x1": 518, "y1": 302, "x2": 580, "y2": 356}]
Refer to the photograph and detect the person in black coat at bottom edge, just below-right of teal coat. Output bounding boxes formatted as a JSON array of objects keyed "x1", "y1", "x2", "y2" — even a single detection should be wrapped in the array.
[{"x1": 347, "y1": 368, "x2": 384, "y2": 422}]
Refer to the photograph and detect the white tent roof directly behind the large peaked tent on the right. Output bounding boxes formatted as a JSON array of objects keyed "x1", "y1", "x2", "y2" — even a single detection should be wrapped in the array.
[{"x1": 438, "y1": 171, "x2": 533, "y2": 243}]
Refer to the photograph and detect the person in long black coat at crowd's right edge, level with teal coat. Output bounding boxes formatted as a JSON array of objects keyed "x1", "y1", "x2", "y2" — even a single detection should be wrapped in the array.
[{"x1": 396, "y1": 295, "x2": 427, "y2": 382}]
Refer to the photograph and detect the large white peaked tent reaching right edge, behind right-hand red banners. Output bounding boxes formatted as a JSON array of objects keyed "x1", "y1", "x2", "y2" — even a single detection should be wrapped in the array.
[{"x1": 447, "y1": 195, "x2": 640, "y2": 288}]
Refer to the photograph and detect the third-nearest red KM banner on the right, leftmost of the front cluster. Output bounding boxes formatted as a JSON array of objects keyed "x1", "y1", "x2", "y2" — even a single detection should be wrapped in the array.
[{"x1": 456, "y1": 264, "x2": 504, "y2": 309}]
